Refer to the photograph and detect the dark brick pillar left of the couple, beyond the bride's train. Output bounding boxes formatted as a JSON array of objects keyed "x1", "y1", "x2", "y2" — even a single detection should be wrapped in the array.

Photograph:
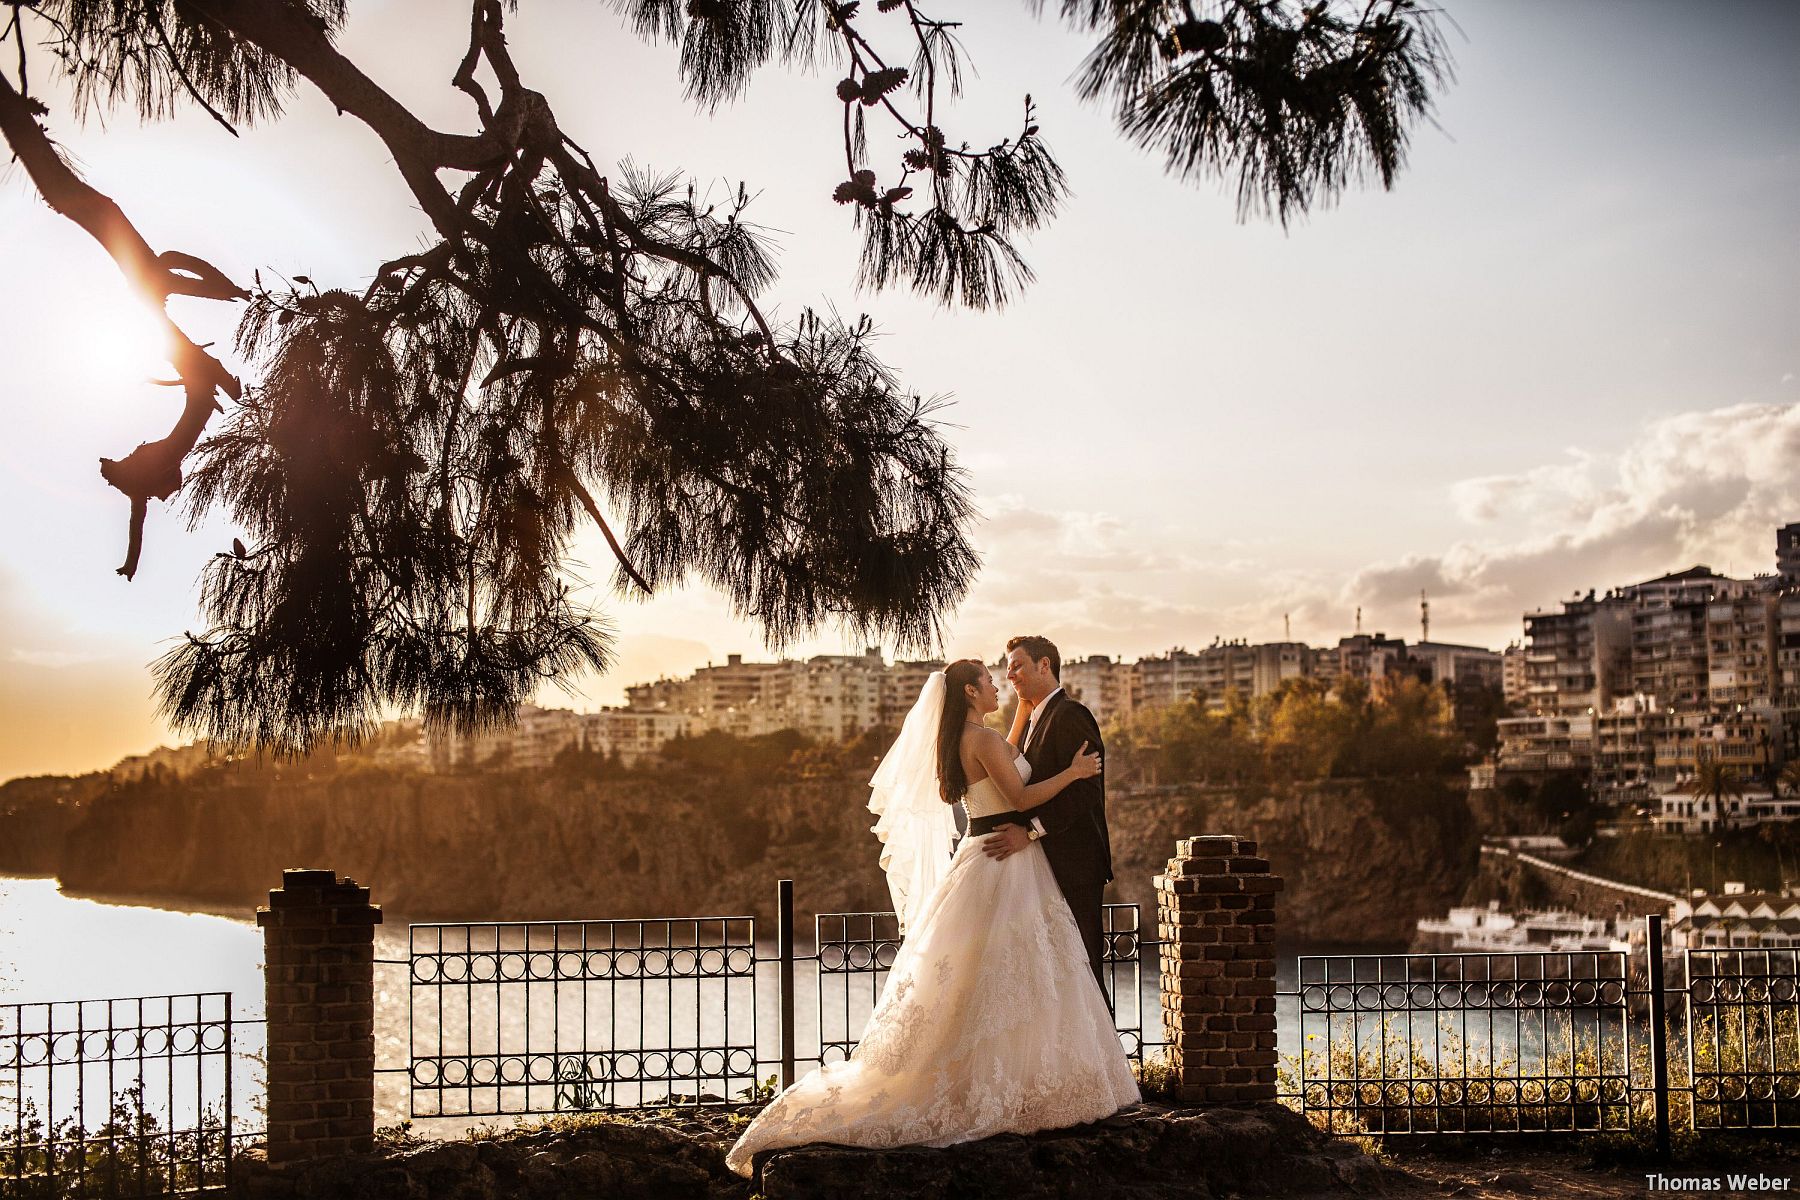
[{"x1": 256, "y1": 871, "x2": 382, "y2": 1162}]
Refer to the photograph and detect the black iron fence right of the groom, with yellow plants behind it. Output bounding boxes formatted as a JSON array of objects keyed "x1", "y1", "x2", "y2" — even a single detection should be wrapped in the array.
[{"x1": 1278, "y1": 916, "x2": 1800, "y2": 1151}]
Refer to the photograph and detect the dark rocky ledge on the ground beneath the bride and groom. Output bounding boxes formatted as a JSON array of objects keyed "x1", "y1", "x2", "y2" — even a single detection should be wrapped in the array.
[{"x1": 232, "y1": 1105, "x2": 1409, "y2": 1200}]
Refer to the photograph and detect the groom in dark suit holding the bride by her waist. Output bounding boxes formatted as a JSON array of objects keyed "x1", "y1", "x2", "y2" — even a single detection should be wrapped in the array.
[{"x1": 970, "y1": 637, "x2": 1112, "y2": 995}]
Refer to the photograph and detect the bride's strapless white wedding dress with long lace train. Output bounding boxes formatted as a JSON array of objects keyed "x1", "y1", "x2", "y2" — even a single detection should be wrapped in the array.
[{"x1": 725, "y1": 759, "x2": 1139, "y2": 1175}]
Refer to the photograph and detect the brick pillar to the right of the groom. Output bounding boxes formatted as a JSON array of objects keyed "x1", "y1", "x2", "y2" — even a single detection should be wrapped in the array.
[{"x1": 1156, "y1": 837, "x2": 1282, "y2": 1105}]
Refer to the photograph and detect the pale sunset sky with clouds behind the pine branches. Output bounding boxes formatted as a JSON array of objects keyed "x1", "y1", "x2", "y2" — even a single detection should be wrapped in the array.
[{"x1": 0, "y1": 0, "x2": 1800, "y2": 779}]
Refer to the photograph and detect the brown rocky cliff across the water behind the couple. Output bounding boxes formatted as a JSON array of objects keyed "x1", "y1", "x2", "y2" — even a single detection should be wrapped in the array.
[{"x1": 0, "y1": 766, "x2": 1478, "y2": 945}]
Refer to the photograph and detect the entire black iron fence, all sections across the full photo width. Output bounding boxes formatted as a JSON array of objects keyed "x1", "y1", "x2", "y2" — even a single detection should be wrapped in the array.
[{"x1": 14, "y1": 882, "x2": 1800, "y2": 1198}]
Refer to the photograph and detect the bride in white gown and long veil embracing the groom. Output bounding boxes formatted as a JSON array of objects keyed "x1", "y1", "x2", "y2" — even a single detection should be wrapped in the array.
[{"x1": 725, "y1": 658, "x2": 1138, "y2": 1175}]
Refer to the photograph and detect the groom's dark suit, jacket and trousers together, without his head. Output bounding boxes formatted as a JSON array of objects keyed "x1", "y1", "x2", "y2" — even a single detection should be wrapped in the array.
[{"x1": 968, "y1": 691, "x2": 1112, "y2": 995}]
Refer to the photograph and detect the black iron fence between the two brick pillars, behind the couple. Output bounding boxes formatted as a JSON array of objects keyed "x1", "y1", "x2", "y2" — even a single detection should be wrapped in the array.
[{"x1": 405, "y1": 882, "x2": 1161, "y2": 1117}]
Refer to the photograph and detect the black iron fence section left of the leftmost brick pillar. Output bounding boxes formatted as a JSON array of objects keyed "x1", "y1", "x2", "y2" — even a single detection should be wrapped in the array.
[{"x1": 0, "y1": 993, "x2": 263, "y2": 1198}]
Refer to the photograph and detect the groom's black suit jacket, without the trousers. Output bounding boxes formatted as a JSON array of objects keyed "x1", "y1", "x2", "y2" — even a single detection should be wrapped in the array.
[{"x1": 1024, "y1": 691, "x2": 1112, "y2": 892}]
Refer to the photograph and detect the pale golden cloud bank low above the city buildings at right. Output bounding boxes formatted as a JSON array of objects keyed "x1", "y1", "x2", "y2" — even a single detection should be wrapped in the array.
[{"x1": 956, "y1": 405, "x2": 1800, "y2": 657}]
